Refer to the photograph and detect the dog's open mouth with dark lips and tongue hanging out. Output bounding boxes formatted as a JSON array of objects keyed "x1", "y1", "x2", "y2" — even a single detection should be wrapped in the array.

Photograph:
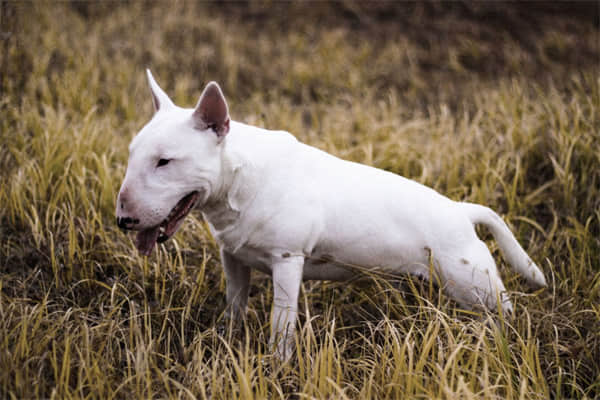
[{"x1": 136, "y1": 192, "x2": 200, "y2": 256}]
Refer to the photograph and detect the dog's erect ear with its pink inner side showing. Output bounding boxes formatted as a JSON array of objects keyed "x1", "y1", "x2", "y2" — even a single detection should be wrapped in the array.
[{"x1": 193, "y1": 82, "x2": 229, "y2": 138}]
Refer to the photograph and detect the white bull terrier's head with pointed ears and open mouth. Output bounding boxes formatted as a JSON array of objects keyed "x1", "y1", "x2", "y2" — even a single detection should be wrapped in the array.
[{"x1": 117, "y1": 70, "x2": 230, "y2": 255}]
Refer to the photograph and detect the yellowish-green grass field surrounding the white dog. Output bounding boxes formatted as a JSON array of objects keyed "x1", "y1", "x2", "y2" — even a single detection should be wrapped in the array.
[{"x1": 0, "y1": 2, "x2": 600, "y2": 399}]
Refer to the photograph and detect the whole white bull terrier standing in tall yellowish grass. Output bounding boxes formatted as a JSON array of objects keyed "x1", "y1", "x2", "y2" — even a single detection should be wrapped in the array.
[{"x1": 117, "y1": 71, "x2": 546, "y2": 358}]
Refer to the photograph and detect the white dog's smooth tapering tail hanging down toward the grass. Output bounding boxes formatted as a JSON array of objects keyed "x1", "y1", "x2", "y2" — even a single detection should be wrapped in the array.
[{"x1": 459, "y1": 203, "x2": 547, "y2": 287}]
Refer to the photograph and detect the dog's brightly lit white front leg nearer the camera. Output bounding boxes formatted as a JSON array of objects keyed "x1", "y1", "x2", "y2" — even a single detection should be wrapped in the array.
[{"x1": 270, "y1": 256, "x2": 304, "y2": 361}]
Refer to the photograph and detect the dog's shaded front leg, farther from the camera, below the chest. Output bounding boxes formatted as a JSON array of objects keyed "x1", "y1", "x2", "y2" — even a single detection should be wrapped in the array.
[{"x1": 221, "y1": 249, "x2": 250, "y2": 323}]
